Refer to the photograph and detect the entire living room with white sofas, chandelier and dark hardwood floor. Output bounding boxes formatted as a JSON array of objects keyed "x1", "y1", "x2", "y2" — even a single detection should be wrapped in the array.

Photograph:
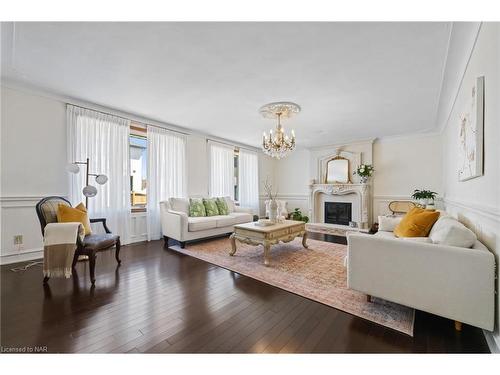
[{"x1": 0, "y1": 0, "x2": 500, "y2": 374}]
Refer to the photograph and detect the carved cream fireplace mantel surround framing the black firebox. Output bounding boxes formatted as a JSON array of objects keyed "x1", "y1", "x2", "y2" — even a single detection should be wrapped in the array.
[{"x1": 309, "y1": 184, "x2": 370, "y2": 228}]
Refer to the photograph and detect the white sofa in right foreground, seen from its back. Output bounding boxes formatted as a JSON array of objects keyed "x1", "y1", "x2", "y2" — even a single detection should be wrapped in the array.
[{"x1": 347, "y1": 215, "x2": 495, "y2": 331}]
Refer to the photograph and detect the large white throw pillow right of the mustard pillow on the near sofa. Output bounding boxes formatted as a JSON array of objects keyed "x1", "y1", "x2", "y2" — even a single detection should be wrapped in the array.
[{"x1": 429, "y1": 216, "x2": 477, "y2": 248}]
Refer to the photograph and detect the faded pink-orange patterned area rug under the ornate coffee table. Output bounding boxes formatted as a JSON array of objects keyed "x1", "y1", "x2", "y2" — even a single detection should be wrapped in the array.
[{"x1": 170, "y1": 238, "x2": 415, "y2": 336}]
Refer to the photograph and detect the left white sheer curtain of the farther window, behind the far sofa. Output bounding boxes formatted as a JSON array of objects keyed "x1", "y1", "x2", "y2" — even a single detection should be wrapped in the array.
[{"x1": 208, "y1": 141, "x2": 234, "y2": 199}]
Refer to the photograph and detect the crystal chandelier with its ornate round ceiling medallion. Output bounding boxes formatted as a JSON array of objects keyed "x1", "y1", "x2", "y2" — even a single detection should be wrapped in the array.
[{"x1": 259, "y1": 102, "x2": 300, "y2": 159}]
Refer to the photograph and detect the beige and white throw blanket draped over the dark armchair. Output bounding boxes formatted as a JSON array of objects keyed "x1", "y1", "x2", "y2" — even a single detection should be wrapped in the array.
[{"x1": 43, "y1": 223, "x2": 85, "y2": 278}]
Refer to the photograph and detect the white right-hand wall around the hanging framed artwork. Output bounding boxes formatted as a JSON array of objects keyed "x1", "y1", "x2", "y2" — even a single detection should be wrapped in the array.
[{"x1": 442, "y1": 23, "x2": 500, "y2": 347}]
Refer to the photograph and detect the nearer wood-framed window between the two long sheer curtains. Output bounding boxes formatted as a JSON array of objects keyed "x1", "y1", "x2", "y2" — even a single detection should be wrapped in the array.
[{"x1": 130, "y1": 131, "x2": 148, "y2": 211}]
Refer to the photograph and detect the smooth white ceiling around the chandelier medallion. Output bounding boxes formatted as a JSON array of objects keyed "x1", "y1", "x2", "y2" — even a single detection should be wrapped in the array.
[{"x1": 2, "y1": 22, "x2": 451, "y2": 147}]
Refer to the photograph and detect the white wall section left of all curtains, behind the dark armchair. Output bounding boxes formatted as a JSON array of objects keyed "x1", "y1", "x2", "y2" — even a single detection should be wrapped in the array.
[{"x1": 0, "y1": 87, "x2": 68, "y2": 262}]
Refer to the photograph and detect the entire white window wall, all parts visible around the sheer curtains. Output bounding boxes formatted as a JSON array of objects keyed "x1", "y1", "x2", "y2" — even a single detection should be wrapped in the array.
[{"x1": 0, "y1": 86, "x2": 274, "y2": 263}]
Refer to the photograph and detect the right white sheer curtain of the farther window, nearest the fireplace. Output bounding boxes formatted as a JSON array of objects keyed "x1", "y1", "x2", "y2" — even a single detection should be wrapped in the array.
[{"x1": 238, "y1": 148, "x2": 259, "y2": 213}]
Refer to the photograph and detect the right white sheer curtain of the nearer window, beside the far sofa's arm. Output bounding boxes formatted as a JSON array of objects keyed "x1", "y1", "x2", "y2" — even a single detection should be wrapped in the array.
[{"x1": 147, "y1": 126, "x2": 186, "y2": 241}]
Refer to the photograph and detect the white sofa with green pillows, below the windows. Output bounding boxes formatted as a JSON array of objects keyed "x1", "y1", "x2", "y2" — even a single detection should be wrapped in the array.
[{"x1": 160, "y1": 197, "x2": 253, "y2": 248}]
